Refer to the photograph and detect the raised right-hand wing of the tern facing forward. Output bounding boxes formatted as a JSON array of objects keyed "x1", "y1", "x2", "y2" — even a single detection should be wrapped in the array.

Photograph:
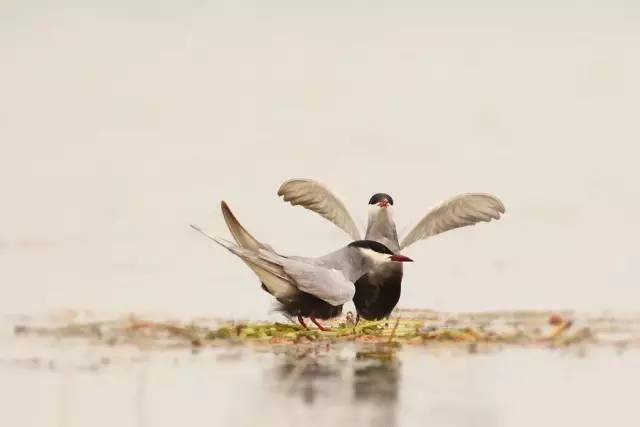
[{"x1": 400, "y1": 193, "x2": 505, "y2": 249}]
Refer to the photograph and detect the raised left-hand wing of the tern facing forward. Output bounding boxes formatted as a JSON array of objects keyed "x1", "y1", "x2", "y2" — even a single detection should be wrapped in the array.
[{"x1": 278, "y1": 179, "x2": 360, "y2": 240}]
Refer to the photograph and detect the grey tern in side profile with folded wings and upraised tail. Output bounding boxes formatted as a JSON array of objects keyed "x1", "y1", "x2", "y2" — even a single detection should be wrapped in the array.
[{"x1": 191, "y1": 201, "x2": 412, "y2": 331}]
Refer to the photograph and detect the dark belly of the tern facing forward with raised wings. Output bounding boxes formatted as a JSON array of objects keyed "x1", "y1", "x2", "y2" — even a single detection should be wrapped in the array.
[{"x1": 353, "y1": 264, "x2": 402, "y2": 320}]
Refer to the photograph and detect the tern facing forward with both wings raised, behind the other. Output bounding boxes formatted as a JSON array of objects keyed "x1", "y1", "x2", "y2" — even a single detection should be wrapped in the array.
[{"x1": 278, "y1": 179, "x2": 505, "y2": 322}]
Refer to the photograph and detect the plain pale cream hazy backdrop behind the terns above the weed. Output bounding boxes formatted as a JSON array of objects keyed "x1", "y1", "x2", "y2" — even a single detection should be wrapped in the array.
[{"x1": 0, "y1": 0, "x2": 640, "y2": 318}]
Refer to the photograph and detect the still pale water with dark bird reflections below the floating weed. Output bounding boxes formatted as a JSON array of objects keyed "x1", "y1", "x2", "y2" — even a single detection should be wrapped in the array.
[{"x1": 0, "y1": 322, "x2": 640, "y2": 427}]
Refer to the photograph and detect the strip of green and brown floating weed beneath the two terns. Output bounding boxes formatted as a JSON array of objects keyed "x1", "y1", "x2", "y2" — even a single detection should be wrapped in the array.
[{"x1": 14, "y1": 310, "x2": 640, "y2": 348}]
